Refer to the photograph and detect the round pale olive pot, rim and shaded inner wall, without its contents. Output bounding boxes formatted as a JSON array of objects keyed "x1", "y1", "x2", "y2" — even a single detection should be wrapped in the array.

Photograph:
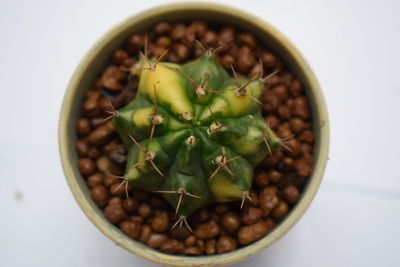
[{"x1": 59, "y1": 2, "x2": 329, "y2": 266}]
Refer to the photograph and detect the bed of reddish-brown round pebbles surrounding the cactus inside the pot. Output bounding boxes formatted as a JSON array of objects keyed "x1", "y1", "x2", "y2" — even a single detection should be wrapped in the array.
[{"x1": 75, "y1": 21, "x2": 316, "y2": 256}]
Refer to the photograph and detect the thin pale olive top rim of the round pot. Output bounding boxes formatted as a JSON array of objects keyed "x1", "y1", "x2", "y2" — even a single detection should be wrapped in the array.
[{"x1": 58, "y1": 1, "x2": 329, "y2": 266}]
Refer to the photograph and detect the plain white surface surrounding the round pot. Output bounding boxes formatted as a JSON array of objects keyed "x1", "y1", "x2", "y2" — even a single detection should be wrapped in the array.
[{"x1": 0, "y1": 0, "x2": 400, "y2": 267}]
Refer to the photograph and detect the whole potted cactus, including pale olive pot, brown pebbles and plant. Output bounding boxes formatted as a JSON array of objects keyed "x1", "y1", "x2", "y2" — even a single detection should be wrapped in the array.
[{"x1": 59, "y1": 2, "x2": 329, "y2": 266}]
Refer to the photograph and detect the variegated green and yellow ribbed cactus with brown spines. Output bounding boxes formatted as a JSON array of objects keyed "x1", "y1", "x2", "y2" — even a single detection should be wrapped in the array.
[{"x1": 112, "y1": 45, "x2": 282, "y2": 229}]
